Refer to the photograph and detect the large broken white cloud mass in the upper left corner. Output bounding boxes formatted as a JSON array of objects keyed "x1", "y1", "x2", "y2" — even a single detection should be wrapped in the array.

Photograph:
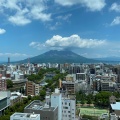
[{"x1": 0, "y1": 0, "x2": 51, "y2": 25}]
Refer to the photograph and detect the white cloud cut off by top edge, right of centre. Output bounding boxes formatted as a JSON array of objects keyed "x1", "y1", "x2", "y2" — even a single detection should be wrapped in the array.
[{"x1": 55, "y1": 0, "x2": 106, "y2": 11}]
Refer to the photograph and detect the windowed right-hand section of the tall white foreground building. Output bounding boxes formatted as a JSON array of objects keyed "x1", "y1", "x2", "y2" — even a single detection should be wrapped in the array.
[{"x1": 62, "y1": 97, "x2": 76, "y2": 120}]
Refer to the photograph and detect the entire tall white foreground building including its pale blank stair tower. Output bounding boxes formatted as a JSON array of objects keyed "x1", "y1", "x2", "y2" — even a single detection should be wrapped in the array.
[{"x1": 50, "y1": 89, "x2": 76, "y2": 120}]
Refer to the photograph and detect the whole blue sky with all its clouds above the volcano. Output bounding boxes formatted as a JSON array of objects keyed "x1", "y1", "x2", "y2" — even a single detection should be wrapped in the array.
[{"x1": 0, "y1": 0, "x2": 120, "y2": 61}]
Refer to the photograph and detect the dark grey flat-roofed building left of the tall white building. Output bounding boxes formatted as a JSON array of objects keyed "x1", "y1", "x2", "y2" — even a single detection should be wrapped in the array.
[{"x1": 24, "y1": 100, "x2": 59, "y2": 120}]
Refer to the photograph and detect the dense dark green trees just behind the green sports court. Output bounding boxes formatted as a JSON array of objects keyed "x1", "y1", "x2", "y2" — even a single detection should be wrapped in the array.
[{"x1": 76, "y1": 91, "x2": 120, "y2": 108}]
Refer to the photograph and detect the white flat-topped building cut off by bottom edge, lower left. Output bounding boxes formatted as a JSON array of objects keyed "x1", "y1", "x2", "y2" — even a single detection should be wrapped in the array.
[{"x1": 10, "y1": 113, "x2": 40, "y2": 120}]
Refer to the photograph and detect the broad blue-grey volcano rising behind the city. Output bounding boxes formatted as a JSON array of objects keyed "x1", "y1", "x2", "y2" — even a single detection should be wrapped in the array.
[{"x1": 18, "y1": 50, "x2": 97, "y2": 63}]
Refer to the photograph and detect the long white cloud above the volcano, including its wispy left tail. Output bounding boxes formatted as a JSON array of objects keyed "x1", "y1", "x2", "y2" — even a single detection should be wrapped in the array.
[{"x1": 29, "y1": 35, "x2": 106, "y2": 49}]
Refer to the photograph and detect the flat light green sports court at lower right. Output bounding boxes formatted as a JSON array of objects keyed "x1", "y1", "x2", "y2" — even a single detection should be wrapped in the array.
[{"x1": 79, "y1": 108, "x2": 108, "y2": 116}]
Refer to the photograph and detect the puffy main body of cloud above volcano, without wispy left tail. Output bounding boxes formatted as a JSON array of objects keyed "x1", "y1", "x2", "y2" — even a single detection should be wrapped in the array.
[{"x1": 45, "y1": 35, "x2": 105, "y2": 48}]
